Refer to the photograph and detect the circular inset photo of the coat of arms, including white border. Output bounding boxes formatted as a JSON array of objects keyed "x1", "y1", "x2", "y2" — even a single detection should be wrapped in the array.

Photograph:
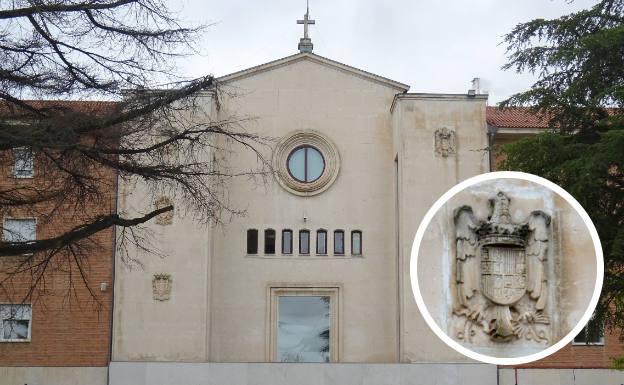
[{"x1": 410, "y1": 172, "x2": 604, "y2": 365}]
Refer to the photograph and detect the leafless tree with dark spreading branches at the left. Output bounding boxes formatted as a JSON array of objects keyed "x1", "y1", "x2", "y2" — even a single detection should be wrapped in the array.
[{"x1": 0, "y1": 0, "x2": 270, "y2": 304}]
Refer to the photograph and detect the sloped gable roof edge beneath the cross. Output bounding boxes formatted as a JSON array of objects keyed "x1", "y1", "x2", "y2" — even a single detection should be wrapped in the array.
[{"x1": 217, "y1": 52, "x2": 409, "y2": 92}]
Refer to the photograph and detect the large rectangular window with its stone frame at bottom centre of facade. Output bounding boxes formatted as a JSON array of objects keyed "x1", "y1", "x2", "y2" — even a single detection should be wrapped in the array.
[{"x1": 271, "y1": 287, "x2": 338, "y2": 362}]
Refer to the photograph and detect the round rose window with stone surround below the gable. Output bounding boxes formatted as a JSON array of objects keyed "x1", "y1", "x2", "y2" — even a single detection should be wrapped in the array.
[{"x1": 273, "y1": 130, "x2": 340, "y2": 196}]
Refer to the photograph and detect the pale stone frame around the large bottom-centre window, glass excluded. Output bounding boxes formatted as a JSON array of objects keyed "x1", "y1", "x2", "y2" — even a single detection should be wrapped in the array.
[{"x1": 266, "y1": 284, "x2": 342, "y2": 364}]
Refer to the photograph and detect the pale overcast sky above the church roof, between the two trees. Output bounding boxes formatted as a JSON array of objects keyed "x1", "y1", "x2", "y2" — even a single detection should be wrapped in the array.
[{"x1": 172, "y1": 0, "x2": 595, "y2": 105}]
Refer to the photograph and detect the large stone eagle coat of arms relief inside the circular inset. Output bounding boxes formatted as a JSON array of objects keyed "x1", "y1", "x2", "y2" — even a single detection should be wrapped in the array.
[{"x1": 452, "y1": 192, "x2": 552, "y2": 344}]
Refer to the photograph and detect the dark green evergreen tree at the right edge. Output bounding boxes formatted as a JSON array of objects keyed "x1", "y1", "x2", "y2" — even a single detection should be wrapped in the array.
[{"x1": 500, "y1": 0, "x2": 624, "y2": 335}]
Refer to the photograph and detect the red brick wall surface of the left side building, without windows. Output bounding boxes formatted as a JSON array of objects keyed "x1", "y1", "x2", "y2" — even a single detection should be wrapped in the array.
[{"x1": 0, "y1": 148, "x2": 115, "y2": 366}]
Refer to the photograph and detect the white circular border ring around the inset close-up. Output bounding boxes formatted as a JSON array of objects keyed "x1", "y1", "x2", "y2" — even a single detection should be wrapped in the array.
[{"x1": 410, "y1": 171, "x2": 604, "y2": 365}]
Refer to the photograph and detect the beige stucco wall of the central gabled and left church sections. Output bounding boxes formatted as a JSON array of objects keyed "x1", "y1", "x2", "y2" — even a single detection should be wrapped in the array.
[{"x1": 113, "y1": 55, "x2": 398, "y2": 362}]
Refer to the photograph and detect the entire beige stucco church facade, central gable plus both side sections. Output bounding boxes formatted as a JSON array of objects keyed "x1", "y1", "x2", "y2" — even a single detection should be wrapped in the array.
[{"x1": 113, "y1": 57, "x2": 488, "y2": 363}]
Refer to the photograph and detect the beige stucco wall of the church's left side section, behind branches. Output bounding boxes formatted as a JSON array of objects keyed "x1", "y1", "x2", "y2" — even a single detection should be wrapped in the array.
[{"x1": 112, "y1": 95, "x2": 217, "y2": 361}]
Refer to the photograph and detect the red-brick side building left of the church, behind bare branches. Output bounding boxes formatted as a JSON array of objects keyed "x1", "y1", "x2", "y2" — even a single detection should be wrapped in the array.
[{"x1": 0, "y1": 101, "x2": 116, "y2": 385}]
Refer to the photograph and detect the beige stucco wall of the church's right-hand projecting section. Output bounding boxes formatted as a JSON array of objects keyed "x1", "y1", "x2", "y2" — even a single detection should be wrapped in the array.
[{"x1": 393, "y1": 94, "x2": 488, "y2": 362}]
